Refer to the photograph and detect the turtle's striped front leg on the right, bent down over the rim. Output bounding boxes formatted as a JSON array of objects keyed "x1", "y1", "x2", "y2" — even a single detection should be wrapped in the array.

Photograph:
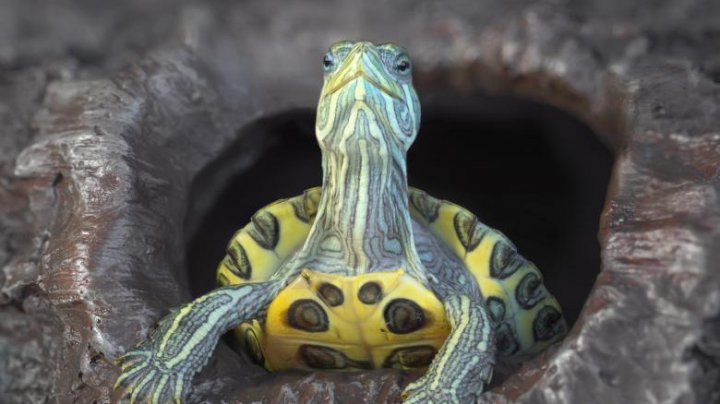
[{"x1": 403, "y1": 295, "x2": 495, "y2": 403}]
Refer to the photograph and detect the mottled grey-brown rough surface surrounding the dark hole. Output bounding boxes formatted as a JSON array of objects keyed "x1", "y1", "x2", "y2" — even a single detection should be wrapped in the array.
[{"x1": 0, "y1": 0, "x2": 720, "y2": 403}]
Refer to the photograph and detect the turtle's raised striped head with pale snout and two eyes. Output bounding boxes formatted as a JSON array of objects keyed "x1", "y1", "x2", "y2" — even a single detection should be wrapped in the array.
[{"x1": 316, "y1": 41, "x2": 420, "y2": 152}]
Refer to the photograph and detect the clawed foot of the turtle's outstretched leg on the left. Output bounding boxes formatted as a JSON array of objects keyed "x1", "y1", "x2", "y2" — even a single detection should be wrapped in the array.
[{"x1": 115, "y1": 348, "x2": 192, "y2": 403}]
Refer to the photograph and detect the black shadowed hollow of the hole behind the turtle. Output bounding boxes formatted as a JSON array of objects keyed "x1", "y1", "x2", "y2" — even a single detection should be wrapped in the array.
[{"x1": 187, "y1": 96, "x2": 612, "y2": 324}]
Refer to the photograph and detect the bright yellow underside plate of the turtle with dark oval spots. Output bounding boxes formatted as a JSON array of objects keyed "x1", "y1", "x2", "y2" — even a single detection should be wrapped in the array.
[{"x1": 238, "y1": 269, "x2": 450, "y2": 370}]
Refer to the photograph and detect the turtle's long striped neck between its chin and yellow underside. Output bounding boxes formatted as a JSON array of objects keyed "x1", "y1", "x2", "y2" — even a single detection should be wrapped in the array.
[{"x1": 300, "y1": 101, "x2": 419, "y2": 274}]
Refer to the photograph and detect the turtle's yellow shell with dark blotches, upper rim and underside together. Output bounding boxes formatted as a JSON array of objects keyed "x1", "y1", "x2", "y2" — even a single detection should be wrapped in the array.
[{"x1": 217, "y1": 187, "x2": 566, "y2": 370}]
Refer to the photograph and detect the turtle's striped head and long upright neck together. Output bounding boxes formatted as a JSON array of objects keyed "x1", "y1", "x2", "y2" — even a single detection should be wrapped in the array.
[{"x1": 296, "y1": 42, "x2": 426, "y2": 281}]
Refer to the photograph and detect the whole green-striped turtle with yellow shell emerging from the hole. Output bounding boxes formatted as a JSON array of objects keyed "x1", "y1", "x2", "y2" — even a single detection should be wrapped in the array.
[{"x1": 116, "y1": 41, "x2": 567, "y2": 403}]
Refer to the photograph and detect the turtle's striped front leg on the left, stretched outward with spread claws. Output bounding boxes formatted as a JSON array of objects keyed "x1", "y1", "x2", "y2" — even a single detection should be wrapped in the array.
[{"x1": 115, "y1": 280, "x2": 281, "y2": 403}]
